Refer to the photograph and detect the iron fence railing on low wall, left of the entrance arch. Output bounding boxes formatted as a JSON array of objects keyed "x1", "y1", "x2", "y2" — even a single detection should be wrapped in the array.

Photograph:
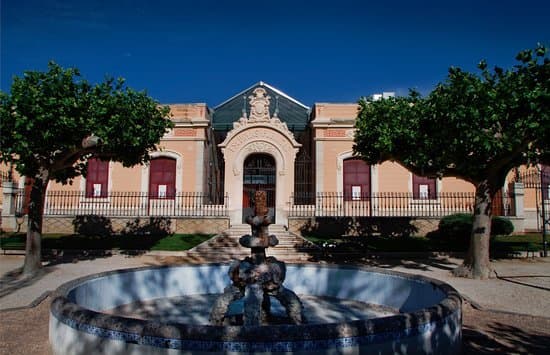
[{"x1": 16, "y1": 191, "x2": 228, "y2": 217}]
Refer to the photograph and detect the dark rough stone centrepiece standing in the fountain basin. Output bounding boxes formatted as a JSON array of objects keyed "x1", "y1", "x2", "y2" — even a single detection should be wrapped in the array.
[{"x1": 210, "y1": 191, "x2": 304, "y2": 325}]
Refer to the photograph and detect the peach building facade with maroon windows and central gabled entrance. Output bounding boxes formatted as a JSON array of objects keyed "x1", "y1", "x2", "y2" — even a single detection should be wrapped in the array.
[{"x1": 2, "y1": 82, "x2": 549, "y2": 235}]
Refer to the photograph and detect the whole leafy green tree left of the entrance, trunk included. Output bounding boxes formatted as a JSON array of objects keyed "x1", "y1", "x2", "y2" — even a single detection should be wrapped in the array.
[{"x1": 0, "y1": 62, "x2": 172, "y2": 274}]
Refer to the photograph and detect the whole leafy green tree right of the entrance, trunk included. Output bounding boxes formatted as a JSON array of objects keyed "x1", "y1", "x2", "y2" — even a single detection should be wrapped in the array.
[{"x1": 354, "y1": 45, "x2": 550, "y2": 278}]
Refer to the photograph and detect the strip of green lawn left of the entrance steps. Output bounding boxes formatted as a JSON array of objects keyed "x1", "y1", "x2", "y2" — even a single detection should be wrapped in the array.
[{"x1": 1, "y1": 233, "x2": 214, "y2": 251}]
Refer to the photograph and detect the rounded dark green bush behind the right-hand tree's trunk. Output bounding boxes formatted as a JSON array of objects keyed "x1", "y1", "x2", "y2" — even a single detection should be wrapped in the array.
[{"x1": 436, "y1": 213, "x2": 514, "y2": 242}]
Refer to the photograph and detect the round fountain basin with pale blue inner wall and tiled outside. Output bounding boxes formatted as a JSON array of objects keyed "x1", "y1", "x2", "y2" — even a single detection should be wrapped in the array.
[{"x1": 49, "y1": 264, "x2": 462, "y2": 354}]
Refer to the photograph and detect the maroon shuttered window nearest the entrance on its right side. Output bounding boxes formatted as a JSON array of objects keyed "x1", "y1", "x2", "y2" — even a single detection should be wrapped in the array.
[{"x1": 344, "y1": 158, "x2": 370, "y2": 201}]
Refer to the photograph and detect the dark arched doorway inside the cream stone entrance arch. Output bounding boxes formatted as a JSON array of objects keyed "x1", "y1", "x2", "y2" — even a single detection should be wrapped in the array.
[{"x1": 243, "y1": 154, "x2": 276, "y2": 223}]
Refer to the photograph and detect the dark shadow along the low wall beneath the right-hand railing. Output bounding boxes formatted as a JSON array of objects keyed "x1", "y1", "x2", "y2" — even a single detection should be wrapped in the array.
[{"x1": 300, "y1": 217, "x2": 418, "y2": 238}]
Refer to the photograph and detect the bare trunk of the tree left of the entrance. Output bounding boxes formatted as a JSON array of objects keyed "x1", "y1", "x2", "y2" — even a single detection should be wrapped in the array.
[{"x1": 23, "y1": 170, "x2": 49, "y2": 275}]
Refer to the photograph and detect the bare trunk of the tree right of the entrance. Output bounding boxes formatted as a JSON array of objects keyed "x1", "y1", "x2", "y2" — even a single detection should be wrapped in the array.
[{"x1": 453, "y1": 181, "x2": 494, "y2": 279}]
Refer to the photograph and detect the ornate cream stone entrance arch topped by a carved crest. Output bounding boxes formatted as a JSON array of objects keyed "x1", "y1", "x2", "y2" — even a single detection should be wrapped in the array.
[{"x1": 219, "y1": 88, "x2": 302, "y2": 225}]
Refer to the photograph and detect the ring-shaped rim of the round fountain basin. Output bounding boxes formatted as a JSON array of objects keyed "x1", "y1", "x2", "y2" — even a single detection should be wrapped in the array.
[{"x1": 50, "y1": 263, "x2": 462, "y2": 342}]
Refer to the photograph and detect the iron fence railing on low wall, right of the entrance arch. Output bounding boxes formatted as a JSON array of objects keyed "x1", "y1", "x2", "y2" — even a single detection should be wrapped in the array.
[{"x1": 289, "y1": 192, "x2": 475, "y2": 217}]
